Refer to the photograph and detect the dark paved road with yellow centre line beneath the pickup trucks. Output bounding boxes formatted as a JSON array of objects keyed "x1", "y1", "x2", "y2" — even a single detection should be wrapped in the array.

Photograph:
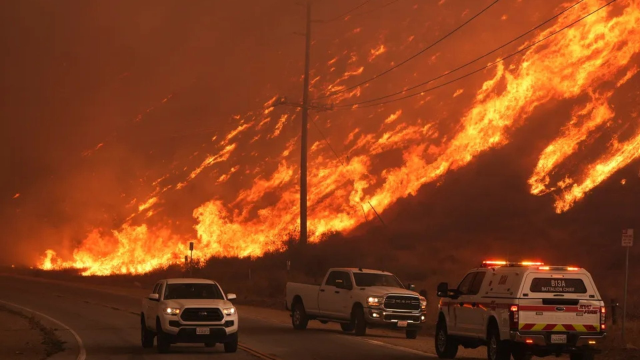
[{"x1": 0, "y1": 276, "x2": 484, "y2": 360}]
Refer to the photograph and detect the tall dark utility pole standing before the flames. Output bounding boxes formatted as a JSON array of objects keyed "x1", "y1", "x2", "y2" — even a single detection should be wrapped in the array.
[{"x1": 300, "y1": 0, "x2": 311, "y2": 246}]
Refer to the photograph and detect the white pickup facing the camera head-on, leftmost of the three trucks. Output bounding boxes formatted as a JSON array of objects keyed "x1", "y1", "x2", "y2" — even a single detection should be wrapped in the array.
[{"x1": 140, "y1": 279, "x2": 238, "y2": 353}]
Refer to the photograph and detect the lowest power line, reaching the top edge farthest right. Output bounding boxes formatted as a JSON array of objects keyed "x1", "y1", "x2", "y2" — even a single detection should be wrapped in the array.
[{"x1": 336, "y1": 0, "x2": 617, "y2": 108}]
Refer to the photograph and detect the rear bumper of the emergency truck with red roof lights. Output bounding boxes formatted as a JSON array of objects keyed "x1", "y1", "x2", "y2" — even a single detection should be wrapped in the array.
[{"x1": 510, "y1": 331, "x2": 606, "y2": 353}]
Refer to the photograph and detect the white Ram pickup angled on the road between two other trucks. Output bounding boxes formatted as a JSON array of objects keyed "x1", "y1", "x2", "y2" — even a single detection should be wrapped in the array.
[{"x1": 286, "y1": 268, "x2": 427, "y2": 339}]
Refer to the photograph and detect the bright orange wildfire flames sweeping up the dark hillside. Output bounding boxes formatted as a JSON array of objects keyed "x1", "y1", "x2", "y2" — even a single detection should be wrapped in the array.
[{"x1": 38, "y1": 0, "x2": 640, "y2": 275}]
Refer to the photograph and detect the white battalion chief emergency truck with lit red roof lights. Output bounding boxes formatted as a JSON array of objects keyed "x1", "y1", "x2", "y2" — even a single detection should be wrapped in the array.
[{"x1": 435, "y1": 261, "x2": 606, "y2": 360}]
